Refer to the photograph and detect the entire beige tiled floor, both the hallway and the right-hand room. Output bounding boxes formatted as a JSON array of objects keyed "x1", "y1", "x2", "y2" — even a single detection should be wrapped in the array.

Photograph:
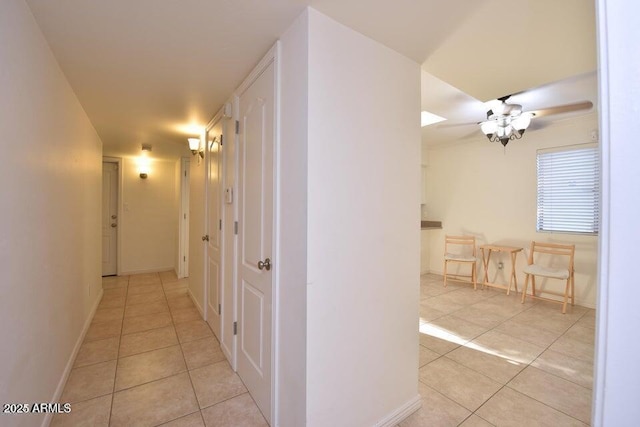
[{"x1": 51, "y1": 272, "x2": 595, "y2": 427}]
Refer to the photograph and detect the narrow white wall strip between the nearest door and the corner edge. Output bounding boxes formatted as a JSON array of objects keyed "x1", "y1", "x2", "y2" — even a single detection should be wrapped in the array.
[{"x1": 274, "y1": 11, "x2": 309, "y2": 427}]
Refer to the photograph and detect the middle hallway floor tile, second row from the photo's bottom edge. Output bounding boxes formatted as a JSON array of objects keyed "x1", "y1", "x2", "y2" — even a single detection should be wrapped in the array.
[{"x1": 115, "y1": 345, "x2": 187, "y2": 391}]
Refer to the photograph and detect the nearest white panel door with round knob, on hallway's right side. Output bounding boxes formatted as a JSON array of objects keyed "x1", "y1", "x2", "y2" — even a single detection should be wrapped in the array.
[{"x1": 237, "y1": 62, "x2": 275, "y2": 422}]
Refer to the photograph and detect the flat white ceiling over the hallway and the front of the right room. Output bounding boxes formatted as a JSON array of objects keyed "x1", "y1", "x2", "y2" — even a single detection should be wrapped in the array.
[{"x1": 27, "y1": 0, "x2": 595, "y2": 156}]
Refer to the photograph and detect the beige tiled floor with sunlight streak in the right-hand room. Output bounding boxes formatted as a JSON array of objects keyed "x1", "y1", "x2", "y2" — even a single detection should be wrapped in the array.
[{"x1": 400, "y1": 275, "x2": 595, "y2": 427}]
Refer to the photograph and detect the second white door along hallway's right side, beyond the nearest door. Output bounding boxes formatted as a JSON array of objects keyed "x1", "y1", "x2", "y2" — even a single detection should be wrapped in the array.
[{"x1": 206, "y1": 123, "x2": 222, "y2": 340}]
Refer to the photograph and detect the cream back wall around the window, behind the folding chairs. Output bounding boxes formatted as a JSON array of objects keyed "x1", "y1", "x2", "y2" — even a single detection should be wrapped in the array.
[{"x1": 427, "y1": 113, "x2": 598, "y2": 307}]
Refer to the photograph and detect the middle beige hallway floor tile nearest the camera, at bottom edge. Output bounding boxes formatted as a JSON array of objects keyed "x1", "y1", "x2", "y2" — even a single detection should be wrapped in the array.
[{"x1": 111, "y1": 372, "x2": 198, "y2": 427}]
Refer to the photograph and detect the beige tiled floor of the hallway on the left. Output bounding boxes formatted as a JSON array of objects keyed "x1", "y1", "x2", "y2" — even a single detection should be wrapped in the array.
[{"x1": 51, "y1": 272, "x2": 268, "y2": 427}]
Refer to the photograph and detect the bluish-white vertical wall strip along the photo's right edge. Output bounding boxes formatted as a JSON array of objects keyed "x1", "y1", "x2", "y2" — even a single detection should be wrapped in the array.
[{"x1": 592, "y1": 0, "x2": 640, "y2": 426}]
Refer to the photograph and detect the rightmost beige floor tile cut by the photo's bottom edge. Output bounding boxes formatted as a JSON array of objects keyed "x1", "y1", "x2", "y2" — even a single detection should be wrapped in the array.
[{"x1": 477, "y1": 387, "x2": 585, "y2": 427}]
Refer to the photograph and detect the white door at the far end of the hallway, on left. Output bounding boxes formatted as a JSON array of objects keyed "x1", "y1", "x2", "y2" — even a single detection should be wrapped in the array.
[{"x1": 102, "y1": 162, "x2": 118, "y2": 276}]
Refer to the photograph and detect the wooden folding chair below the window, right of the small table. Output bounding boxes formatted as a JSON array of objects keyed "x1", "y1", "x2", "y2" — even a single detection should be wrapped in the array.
[{"x1": 522, "y1": 241, "x2": 576, "y2": 314}]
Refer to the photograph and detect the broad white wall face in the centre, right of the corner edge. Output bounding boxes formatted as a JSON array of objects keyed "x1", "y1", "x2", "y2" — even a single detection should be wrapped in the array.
[{"x1": 304, "y1": 9, "x2": 421, "y2": 426}]
